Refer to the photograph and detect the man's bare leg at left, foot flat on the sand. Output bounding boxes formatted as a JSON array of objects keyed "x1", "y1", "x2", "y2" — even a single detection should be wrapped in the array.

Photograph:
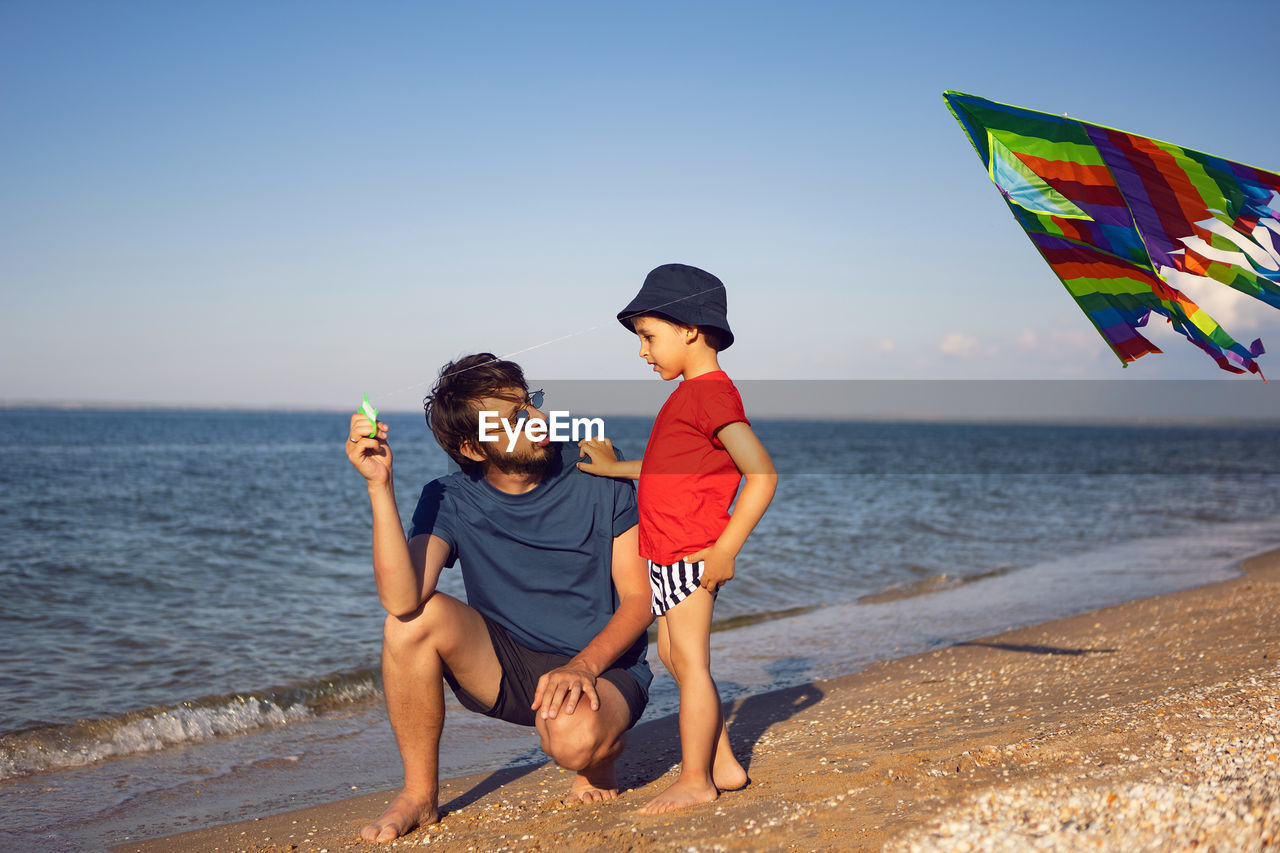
[{"x1": 360, "y1": 593, "x2": 502, "y2": 841}]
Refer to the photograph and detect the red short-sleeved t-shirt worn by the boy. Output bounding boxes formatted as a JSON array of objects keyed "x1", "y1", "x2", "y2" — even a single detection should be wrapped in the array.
[{"x1": 636, "y1": 370, "x2": 750, "y2": 566}]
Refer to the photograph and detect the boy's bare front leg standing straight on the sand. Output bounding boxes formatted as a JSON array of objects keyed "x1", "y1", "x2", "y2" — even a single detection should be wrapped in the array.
[{"x1": 640, "y1": 588, "x2": 736, "y2": 815}]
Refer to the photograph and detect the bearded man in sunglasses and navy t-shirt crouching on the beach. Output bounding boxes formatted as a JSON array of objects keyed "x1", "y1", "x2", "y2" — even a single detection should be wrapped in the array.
[{"x1": 347, "y1": 352, "x2": 652, "y2": 841}]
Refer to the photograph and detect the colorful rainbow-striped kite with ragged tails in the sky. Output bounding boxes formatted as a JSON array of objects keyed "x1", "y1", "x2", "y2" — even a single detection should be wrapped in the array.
[{"x1": 943, "y1": 92, "x2": 1280, "y2": 373}]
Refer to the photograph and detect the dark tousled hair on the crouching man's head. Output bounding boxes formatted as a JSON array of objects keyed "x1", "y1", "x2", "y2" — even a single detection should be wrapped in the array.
[{"x1": 422, "y1": 352, "x2": 529, "y2": 474}]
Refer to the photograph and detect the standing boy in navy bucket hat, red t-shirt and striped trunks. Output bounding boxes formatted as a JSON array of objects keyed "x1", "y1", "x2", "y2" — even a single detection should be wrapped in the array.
[{"x1": 580, "y1": 264, "x2": 777, "y2": 815}]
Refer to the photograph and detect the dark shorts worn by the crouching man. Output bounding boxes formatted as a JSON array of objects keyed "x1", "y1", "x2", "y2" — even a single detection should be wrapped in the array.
[{"x1": 444, "y1": 613, "x2": 649, "y2": 729}]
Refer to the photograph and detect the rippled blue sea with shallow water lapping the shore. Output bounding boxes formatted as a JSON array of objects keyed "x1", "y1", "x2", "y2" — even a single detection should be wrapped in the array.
[{"x1": 0, "y1": 409, "x2": 1280, "y2": 850}]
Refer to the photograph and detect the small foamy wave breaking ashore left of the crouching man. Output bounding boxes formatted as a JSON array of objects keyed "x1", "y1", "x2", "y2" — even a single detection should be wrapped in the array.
[{"x1": 0, "y1": 670, "x2": 381, "y2": 780}]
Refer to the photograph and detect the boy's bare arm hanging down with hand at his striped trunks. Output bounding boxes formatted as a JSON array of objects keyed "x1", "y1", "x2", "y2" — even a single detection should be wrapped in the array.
[{"x1": 685, "y1": 421, "x2": 778, "y2": 592}]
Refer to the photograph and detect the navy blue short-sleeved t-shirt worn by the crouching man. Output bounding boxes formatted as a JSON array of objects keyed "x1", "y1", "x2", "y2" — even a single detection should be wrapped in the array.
[{"x1": 410, "y1": 443, "x2": 653, "y2": 692}]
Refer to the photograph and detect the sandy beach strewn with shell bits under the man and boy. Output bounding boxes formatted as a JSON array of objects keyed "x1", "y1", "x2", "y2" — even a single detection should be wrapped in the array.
[{"x1": 113, "y1": 551, "x2": 1280, "y2": 853}]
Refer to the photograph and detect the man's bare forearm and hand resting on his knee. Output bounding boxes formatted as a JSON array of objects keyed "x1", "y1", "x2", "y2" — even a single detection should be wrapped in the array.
[{"x1": 532, "y1": 526, "x2": 653, "y2": 720}]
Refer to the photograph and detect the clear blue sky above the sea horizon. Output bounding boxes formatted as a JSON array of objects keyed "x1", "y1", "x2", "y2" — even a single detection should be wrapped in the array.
[{"x1": 0, "y1": 0, "x2": 1280, "y2": 411}]
